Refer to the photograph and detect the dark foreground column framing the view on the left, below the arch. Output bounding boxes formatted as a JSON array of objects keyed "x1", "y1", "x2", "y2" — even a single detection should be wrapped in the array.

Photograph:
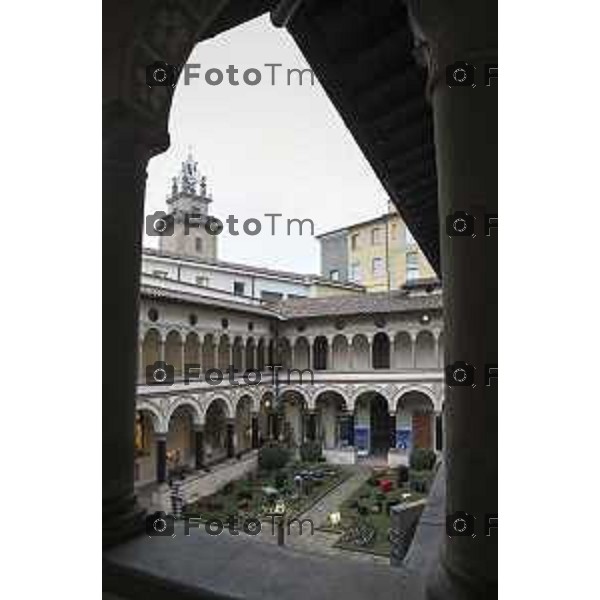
[{"x1": 102, "y1": 106, "x2": 168, "y2": 546}]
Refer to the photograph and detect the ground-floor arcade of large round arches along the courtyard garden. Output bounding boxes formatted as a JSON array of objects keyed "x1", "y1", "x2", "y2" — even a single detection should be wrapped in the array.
[{"x1": 135, "y1": 389, "x2": 442, "y2": 485}]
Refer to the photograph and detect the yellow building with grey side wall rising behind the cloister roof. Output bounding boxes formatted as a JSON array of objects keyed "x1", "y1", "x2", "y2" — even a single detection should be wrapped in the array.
[{"x1": 317, "y1": 207, "x2": 435, "y2": 292}]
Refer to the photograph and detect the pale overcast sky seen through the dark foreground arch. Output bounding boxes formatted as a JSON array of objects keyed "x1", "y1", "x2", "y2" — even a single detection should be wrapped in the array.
[{"x1": 144, "y1": 16, "x2": 387, "y2": 273}]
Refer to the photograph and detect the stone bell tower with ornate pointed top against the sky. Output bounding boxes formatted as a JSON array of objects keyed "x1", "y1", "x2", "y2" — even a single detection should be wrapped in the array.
[{"x1": 159, "y1": 151, "x2": 218, "y2": 259}]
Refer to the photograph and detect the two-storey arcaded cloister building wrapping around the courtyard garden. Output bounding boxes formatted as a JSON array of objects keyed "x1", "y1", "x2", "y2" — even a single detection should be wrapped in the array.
[{"x1": 135, "y1": 284, "x2": 444, "y2": 485}]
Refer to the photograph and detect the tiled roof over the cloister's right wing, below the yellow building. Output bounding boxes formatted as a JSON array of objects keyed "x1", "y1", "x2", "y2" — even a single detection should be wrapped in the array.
[{"x1": 278, "y1": 290, "x2": 442, "y2": 319}]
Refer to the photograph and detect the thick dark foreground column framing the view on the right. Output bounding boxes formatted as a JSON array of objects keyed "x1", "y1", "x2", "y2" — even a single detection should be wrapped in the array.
[{"x1": 408, "y1": 0, "x2": 498, "y2": 600}]
